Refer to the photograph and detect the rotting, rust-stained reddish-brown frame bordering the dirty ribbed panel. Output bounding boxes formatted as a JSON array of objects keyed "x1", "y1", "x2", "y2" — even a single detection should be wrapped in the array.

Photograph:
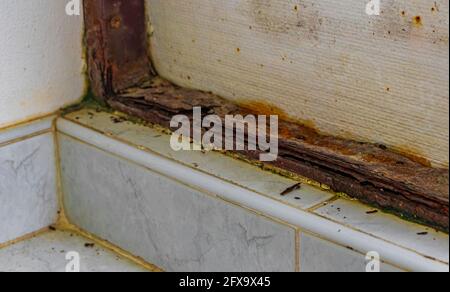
[{"x1": 84, "y1": 0, "x2": 449, "y2": 232}]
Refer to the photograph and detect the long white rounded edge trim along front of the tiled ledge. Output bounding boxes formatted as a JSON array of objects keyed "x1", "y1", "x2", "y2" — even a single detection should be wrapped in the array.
[{"x1": 57, "y1": 118, "x2": 449, "y2": 272}]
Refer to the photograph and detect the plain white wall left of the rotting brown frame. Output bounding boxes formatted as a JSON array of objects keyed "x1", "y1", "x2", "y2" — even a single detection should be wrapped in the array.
[{"x1": 0, "y1": 0, "x2": 85, "y2": 128}]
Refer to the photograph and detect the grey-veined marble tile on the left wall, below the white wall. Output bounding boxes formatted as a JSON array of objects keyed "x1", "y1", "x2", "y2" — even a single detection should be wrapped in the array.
[{"x1": 0, "y1": 133, "x2": 58, "y2": 243}]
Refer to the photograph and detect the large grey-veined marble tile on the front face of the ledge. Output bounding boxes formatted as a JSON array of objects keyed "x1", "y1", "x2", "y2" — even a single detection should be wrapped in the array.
[{"x1": 59, "y1": 135, "x2": 295, "y2": 271}]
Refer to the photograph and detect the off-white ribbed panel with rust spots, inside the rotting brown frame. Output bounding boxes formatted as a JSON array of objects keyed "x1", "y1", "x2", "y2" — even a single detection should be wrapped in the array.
[{"x1": 148, "y1": 0, "x2": 449, "y2": 166}]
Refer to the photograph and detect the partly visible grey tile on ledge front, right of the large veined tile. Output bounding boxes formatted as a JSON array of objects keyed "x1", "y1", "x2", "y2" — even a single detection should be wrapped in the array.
[{"x1": 300, "y1": 233, "x2": 401, "y2": 272}]
